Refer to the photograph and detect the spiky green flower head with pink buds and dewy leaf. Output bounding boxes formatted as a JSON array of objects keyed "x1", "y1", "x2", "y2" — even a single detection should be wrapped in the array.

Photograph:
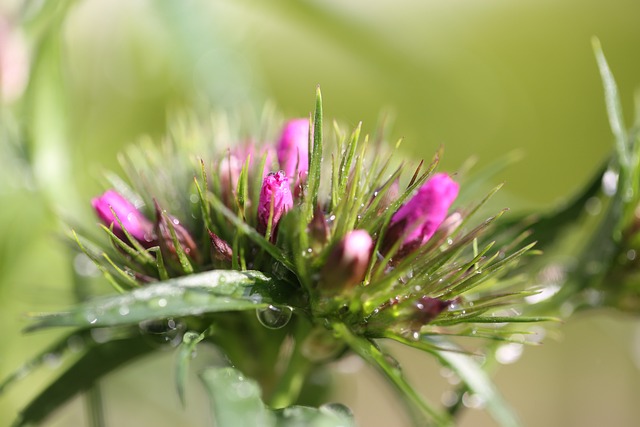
[{"x1": 25, "y1": 92, "x2": 542, "y2": 425}]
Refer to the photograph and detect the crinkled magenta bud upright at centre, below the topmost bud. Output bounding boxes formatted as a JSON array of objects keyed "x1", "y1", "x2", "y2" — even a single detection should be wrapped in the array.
[{"x1": 258, "y1": 171, "x2": 293, "y2": 241}]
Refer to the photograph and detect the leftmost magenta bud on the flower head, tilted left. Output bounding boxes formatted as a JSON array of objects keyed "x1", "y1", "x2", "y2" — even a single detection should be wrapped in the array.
[{"x1": 91, "y1": 190, "x2": 156, "y2": 248}]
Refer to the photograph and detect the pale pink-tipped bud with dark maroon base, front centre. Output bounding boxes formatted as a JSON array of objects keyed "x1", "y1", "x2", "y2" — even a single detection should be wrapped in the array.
[{"x1": 320, "y1": 230, "x2": 373, "y2": 291}]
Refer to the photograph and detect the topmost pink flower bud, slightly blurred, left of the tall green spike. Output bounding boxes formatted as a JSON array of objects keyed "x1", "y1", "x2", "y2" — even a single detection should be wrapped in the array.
[{"x1": 277, "y1": 119, "x2": 309, "y2": 178}]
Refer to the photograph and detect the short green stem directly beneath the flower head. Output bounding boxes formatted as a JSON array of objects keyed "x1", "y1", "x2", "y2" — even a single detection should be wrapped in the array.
[{"x1": 269, "y1": 318, "x2": 313, "y2": 409}]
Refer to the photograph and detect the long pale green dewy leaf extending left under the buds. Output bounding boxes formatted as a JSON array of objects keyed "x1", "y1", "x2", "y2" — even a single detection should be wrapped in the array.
[{"x1": 27, "y1": 270, "x2": 276, "y2": 331}]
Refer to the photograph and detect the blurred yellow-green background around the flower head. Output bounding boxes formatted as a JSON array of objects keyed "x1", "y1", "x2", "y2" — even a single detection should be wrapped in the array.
[{"x1": 0, "y1": 0, "x2": 640, "y2": 426}]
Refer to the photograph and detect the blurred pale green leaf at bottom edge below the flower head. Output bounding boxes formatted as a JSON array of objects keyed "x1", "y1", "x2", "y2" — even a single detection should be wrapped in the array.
[{"x1": 200, "y1": 368, "x2": 355, "y2": 427}]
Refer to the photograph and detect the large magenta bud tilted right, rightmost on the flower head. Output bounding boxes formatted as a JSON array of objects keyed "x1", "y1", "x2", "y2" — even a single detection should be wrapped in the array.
[{"x1": 384, "y1": 173, "x2": 460, "y2": 249}]
